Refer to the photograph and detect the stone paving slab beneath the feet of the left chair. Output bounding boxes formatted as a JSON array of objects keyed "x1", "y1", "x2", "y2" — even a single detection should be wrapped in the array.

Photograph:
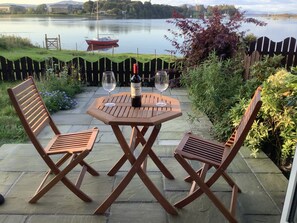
[{"x1": 0, "y1": 172, "x2": 114, "y2": 215}]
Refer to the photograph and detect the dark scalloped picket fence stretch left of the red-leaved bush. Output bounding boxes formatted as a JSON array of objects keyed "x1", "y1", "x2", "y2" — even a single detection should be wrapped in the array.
[{"x1": 0, "y1": 56, "x2": 180, "y2": 86}]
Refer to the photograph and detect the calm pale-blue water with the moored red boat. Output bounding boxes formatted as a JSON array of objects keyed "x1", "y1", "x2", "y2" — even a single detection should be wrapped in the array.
[{"x1": 0, "y1": 17, "x2": 297, "y2": 54}]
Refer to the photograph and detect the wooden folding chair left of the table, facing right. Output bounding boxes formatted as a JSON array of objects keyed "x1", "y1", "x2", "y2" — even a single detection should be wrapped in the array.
[{"x1": 7, "y1": 77, "x2": 99, "y2": 203}]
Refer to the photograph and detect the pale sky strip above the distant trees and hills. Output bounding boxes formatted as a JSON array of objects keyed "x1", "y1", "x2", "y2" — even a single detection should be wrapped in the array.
[{"x1": 0, "y1": 0, "x2": 297, "y2": 13}]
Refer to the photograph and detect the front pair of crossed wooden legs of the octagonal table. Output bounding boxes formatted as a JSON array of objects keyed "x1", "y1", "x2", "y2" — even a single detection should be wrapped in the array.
[{"x1": 95, "y1": 125, "x2": 177, "y2": 215}]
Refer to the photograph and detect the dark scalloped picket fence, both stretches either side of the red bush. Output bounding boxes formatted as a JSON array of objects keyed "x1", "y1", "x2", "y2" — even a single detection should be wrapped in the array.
[{"x1": 0, "y1": 37, "x2": 297, "y2": 86}]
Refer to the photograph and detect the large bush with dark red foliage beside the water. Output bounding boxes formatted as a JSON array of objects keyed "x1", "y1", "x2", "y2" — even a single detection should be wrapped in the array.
[{"x1": 165, "y1": 7, "x2": 266, "y2": 66}]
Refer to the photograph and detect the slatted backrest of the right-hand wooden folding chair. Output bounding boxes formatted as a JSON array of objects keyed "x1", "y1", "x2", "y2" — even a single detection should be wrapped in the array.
[{"x1": 222, "y1": 87, "x2": 262, "y2": 169}]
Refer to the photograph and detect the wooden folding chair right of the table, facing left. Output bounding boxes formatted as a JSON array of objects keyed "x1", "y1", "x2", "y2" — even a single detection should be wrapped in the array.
[{"x1": 174, "y1": 87, "x2": 262, "y2": 222}]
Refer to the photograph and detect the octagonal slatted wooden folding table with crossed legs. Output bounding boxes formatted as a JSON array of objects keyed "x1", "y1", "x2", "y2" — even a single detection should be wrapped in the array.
[{"x1": 87, "y1": 92, "x2": 182, "y2": 215}]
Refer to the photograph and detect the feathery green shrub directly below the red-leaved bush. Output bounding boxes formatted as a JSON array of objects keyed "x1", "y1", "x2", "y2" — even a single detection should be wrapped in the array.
[{"x1": 182, "y1": 53, "x2": 242, "y2": 134}]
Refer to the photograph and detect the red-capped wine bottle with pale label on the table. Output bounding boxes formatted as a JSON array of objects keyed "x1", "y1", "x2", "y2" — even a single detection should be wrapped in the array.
[{"x1": 131, "y1": 63, "x2": 141, "y2": 107}]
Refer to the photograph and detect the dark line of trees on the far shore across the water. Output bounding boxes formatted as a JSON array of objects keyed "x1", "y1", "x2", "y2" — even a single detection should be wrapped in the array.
[{"x1": 1, "y1": 0, "x2": 237, "y2": 19}]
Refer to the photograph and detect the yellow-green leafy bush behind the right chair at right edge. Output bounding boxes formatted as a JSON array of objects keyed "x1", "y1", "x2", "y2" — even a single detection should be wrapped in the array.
[{"x1": 229, "y1": 69, "x2": 297, "y2": 169}]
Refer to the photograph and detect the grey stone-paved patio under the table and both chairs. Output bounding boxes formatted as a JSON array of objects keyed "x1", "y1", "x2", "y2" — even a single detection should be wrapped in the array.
[{"x1": 0, "y1": 87, "x2": 288, "y2": 223}]
